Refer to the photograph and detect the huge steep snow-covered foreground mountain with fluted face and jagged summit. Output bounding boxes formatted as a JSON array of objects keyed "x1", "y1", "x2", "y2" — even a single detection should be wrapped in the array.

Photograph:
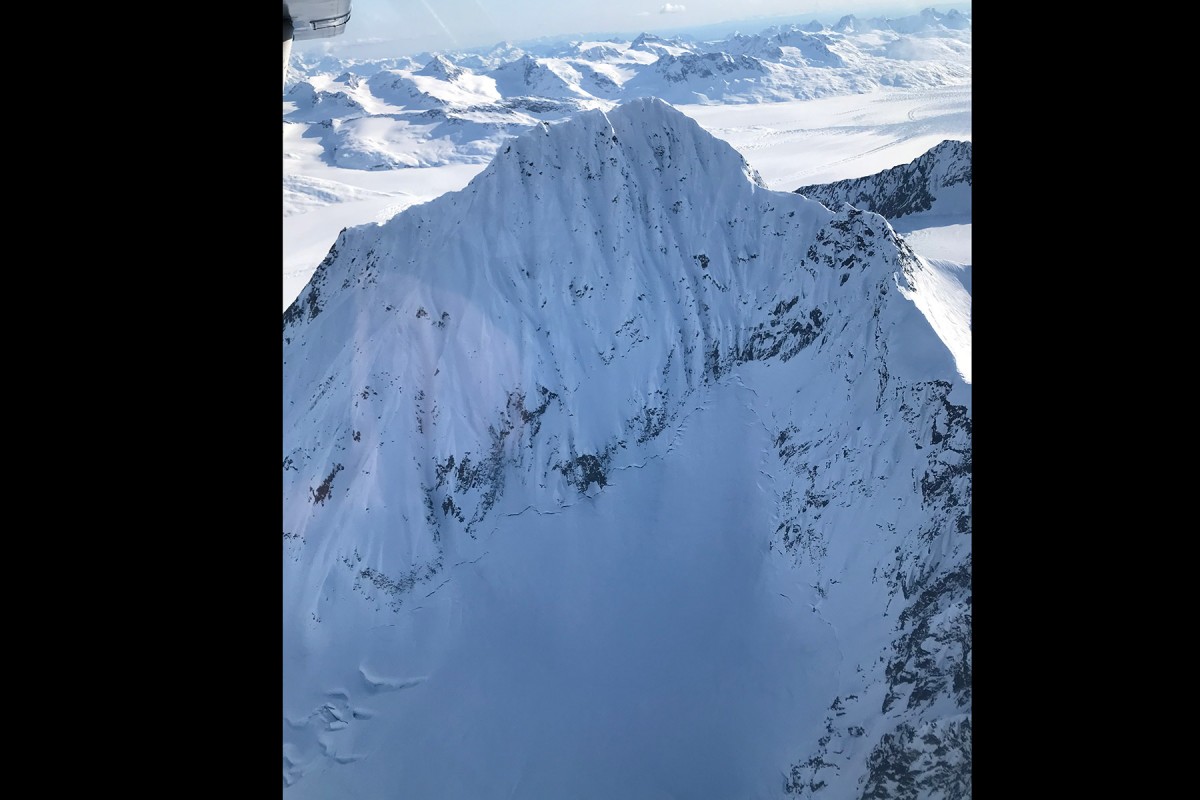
[{"x1": 283, "y1": 100, "x2": 971, "y2": 798}]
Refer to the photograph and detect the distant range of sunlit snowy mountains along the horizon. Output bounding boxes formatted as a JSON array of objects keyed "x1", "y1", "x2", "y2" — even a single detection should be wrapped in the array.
[{"x1": 283, "y1": 10, "x2": 971, "y2": 170}]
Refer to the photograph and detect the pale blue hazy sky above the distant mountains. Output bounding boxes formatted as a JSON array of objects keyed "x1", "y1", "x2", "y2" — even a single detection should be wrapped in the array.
[{"x1": 295, "y1": 0, "x2": 971, "y2": 58}]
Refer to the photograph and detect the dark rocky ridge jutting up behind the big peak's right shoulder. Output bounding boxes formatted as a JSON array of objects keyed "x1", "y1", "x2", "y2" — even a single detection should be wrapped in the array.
[{"x1": 796, "y1": 140, "x2": 971, "y2": 219}]
